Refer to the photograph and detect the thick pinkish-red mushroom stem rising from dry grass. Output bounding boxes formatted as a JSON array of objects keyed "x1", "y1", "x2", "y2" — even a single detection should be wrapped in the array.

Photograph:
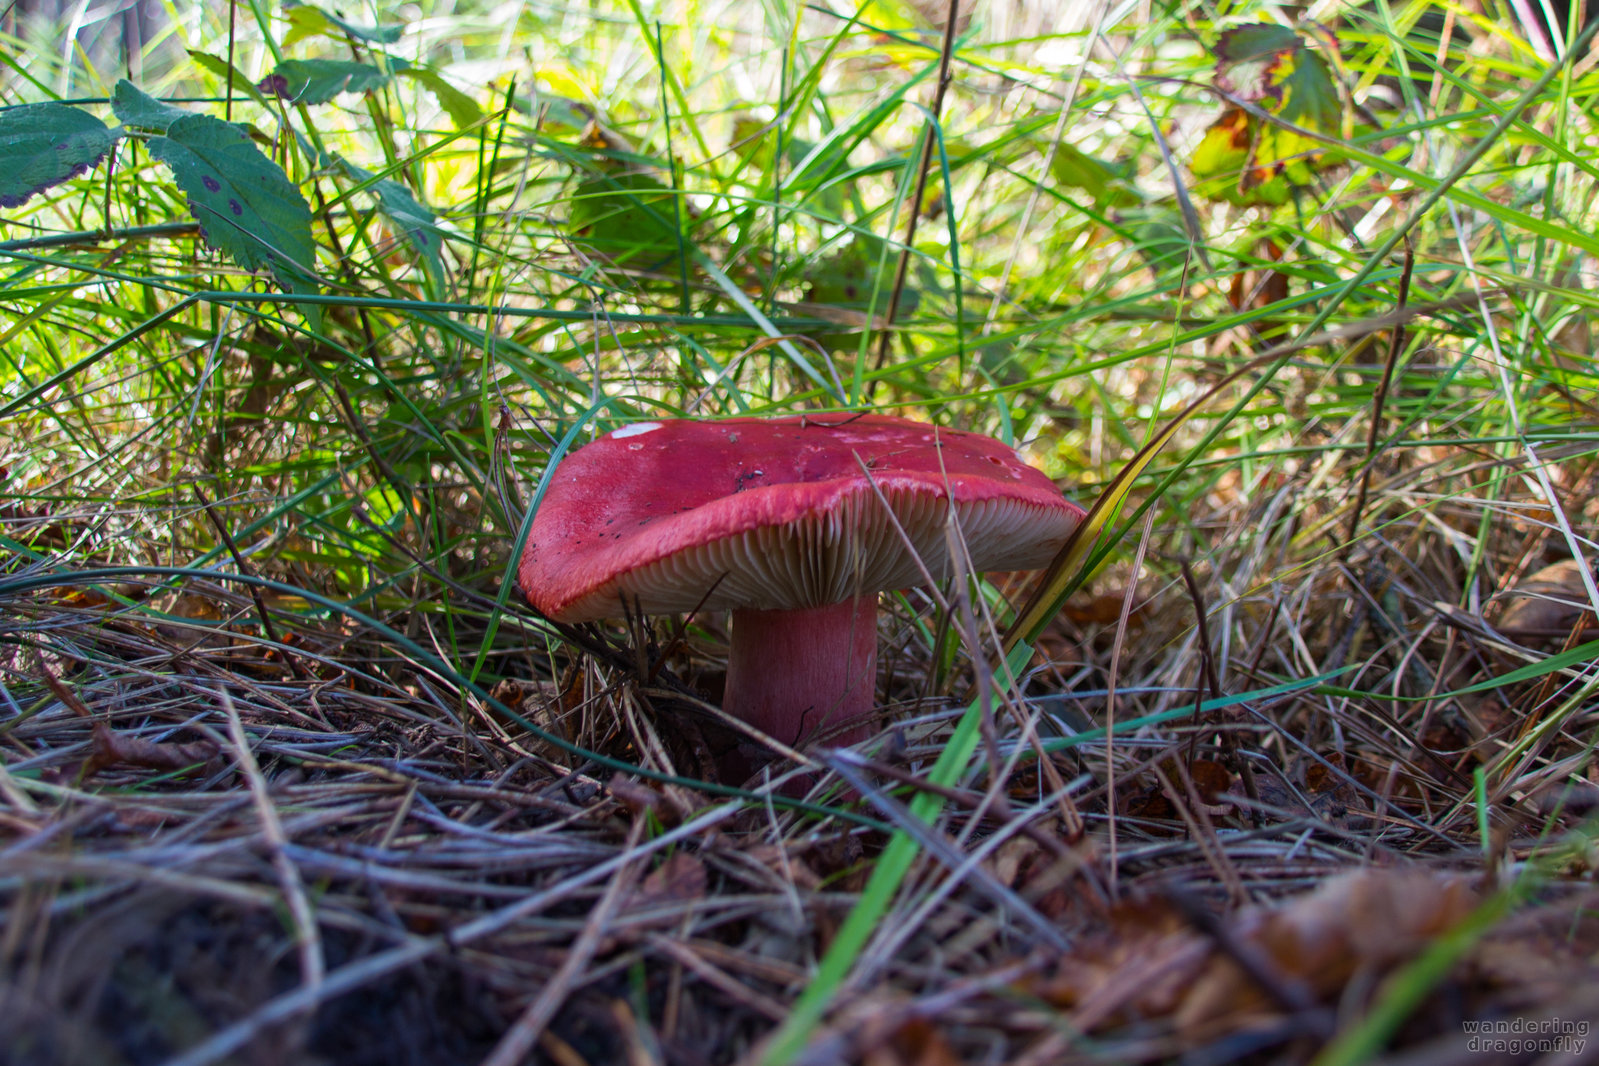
[{"x1": 723, "y1": 593, "x2": 878, "y2": 745}]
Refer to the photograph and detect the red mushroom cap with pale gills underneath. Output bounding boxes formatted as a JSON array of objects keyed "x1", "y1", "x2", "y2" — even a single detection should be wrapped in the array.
[{"x1": 518, "y1": 414, "x2": 1083, "y2": 622}]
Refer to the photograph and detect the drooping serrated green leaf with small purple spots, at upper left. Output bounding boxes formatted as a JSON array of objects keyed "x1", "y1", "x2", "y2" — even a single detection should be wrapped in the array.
[{"x1": 149, "y1": 115, "x2": 317, "y2": 292}]
